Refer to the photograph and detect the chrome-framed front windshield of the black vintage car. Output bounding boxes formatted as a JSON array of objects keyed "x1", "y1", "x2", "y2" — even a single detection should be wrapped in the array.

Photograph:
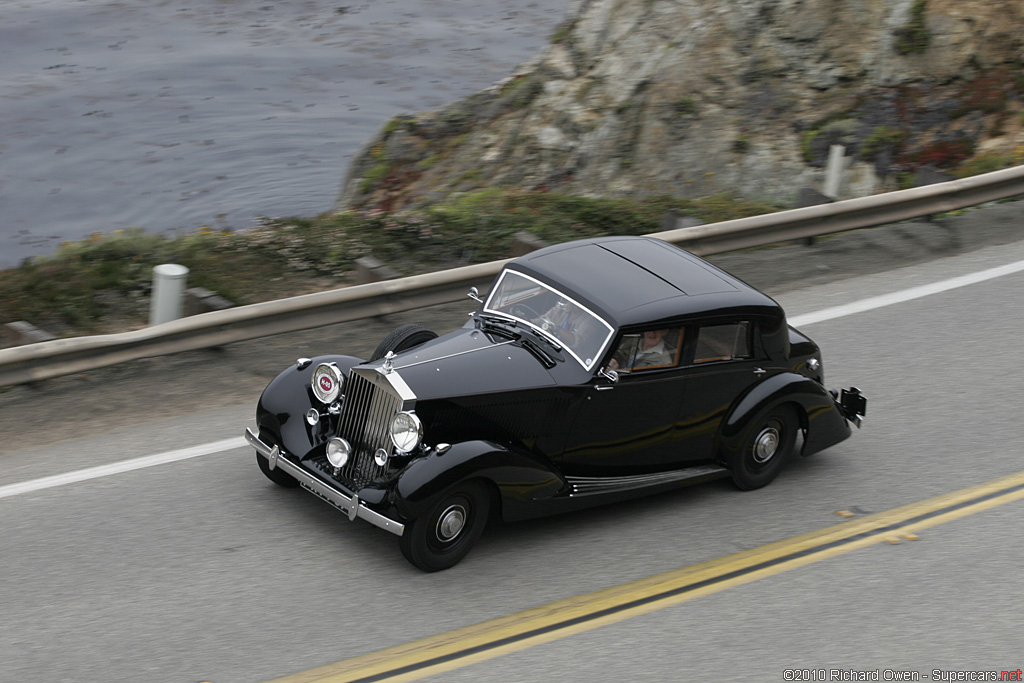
[{"x1": 483, "y1": 270, "x2": 613, "y2": 370}]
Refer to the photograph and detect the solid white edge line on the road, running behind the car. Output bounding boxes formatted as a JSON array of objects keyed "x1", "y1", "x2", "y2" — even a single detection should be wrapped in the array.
[{"x1": 6, "y1": 253, "x2": 1024, "y2": 498}]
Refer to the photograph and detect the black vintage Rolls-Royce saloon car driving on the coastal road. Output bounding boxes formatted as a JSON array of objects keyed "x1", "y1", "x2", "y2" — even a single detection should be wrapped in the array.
[{"x1": 246, "y1": 238, "x2": 866, "y2": 571}]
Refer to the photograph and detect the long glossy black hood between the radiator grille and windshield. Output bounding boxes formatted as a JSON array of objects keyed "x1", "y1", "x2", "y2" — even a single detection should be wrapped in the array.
[{"x1": 385, "y1": 329, "x2": 555, "y2": 400}]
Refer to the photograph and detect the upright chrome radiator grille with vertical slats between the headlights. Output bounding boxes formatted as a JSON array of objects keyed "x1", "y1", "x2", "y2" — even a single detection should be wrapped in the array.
[{"x1": 329, "y1": 368, "x2": 408, "y2": 488}]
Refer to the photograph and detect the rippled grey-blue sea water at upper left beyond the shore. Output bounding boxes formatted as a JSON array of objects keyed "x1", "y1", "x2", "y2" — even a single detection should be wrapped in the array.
[{"x1": 0, "y1": 0, "x2": 568, "y2": 267}]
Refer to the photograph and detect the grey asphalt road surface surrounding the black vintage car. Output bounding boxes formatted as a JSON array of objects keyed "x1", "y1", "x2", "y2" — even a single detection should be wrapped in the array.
[{"x1": 0, "y1": 205, "x2": 1024, "y2": 683}]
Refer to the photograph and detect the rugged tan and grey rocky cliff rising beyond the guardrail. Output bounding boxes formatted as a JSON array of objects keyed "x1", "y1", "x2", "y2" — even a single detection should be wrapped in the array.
[{"x1": 339, "y1": 0, "x2": 1024, "y2": 210}]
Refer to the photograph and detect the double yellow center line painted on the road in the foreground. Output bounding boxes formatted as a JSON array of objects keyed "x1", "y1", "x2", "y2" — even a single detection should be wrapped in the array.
[{"x1": 273, "y1": 472, "x2": 1024, "y2": 683}]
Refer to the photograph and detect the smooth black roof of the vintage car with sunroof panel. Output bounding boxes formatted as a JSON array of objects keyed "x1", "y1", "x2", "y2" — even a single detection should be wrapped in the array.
[{"x1": 506, "y1": 237, "x2": 783, "y2": 327}]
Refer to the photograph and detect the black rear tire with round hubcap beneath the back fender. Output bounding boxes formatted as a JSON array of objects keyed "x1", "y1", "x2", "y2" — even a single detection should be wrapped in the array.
[{"x1": 729, "y1": 405, "x2": 800, "y2": 490}]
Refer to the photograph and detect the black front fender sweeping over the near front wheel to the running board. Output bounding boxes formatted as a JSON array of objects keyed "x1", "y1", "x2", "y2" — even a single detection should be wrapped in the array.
[{"x1": 394, "y1": 440, "x2": 566, "y2": 521}]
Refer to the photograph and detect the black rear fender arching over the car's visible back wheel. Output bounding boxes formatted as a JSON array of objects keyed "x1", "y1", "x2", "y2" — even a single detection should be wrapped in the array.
[{"x1": 718, "y1": 372, "x2": 850, "y2": 462}]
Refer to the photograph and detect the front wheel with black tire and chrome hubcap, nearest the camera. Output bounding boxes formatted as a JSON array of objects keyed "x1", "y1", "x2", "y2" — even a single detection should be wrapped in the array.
[{"x1": 398, "y1": 481, "x2": 490, "y2": 571}]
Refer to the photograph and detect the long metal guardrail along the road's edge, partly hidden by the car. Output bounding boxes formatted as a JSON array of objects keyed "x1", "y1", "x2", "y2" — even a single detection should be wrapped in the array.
[{"x1": 0, "y1": 166, "x2": 1024, "y2": 386}]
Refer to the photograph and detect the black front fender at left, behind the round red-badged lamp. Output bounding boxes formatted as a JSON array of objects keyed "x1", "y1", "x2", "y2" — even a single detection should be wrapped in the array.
[{"x1": 256, "y1": 354, "x2": 362, "y2": 457}]
